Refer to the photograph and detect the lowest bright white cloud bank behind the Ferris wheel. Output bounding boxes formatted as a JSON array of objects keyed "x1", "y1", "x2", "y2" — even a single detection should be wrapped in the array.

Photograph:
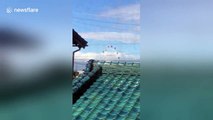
[{"x1": 75, "y1": 52, "x2": 140, "y2": 61}]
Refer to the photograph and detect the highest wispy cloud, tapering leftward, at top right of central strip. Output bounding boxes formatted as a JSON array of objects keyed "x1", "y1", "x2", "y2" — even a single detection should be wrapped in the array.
[{"x1": 100, "y1": 4, "x2": 140, "y2": 23}]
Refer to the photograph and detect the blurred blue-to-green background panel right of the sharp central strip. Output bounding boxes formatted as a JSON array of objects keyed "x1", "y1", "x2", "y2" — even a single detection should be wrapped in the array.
[{"x1": 141, "y1": 0, "x2": 213, "y2": 120}]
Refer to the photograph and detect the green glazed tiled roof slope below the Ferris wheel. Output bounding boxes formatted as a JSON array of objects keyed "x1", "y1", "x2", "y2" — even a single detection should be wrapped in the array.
[{"x1": 73, "y1": 62, "x2": 140, "y2": 120}]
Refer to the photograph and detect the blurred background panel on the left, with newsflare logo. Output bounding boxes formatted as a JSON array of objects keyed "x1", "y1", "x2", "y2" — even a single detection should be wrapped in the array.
[{"x1": 0, "y1": 0, "x2": 72, "y2": 120}]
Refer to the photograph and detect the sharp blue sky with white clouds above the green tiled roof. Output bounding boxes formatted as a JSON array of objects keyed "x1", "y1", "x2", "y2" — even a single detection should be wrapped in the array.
[{"x1": 72, "y1": 0, "x2": 140, "y2": 60}]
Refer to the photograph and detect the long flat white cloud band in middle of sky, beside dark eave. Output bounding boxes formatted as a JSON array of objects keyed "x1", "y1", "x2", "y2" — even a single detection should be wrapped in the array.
[{"x1": 80, "y1": 32, "x2": 140, "y2": 43}]
